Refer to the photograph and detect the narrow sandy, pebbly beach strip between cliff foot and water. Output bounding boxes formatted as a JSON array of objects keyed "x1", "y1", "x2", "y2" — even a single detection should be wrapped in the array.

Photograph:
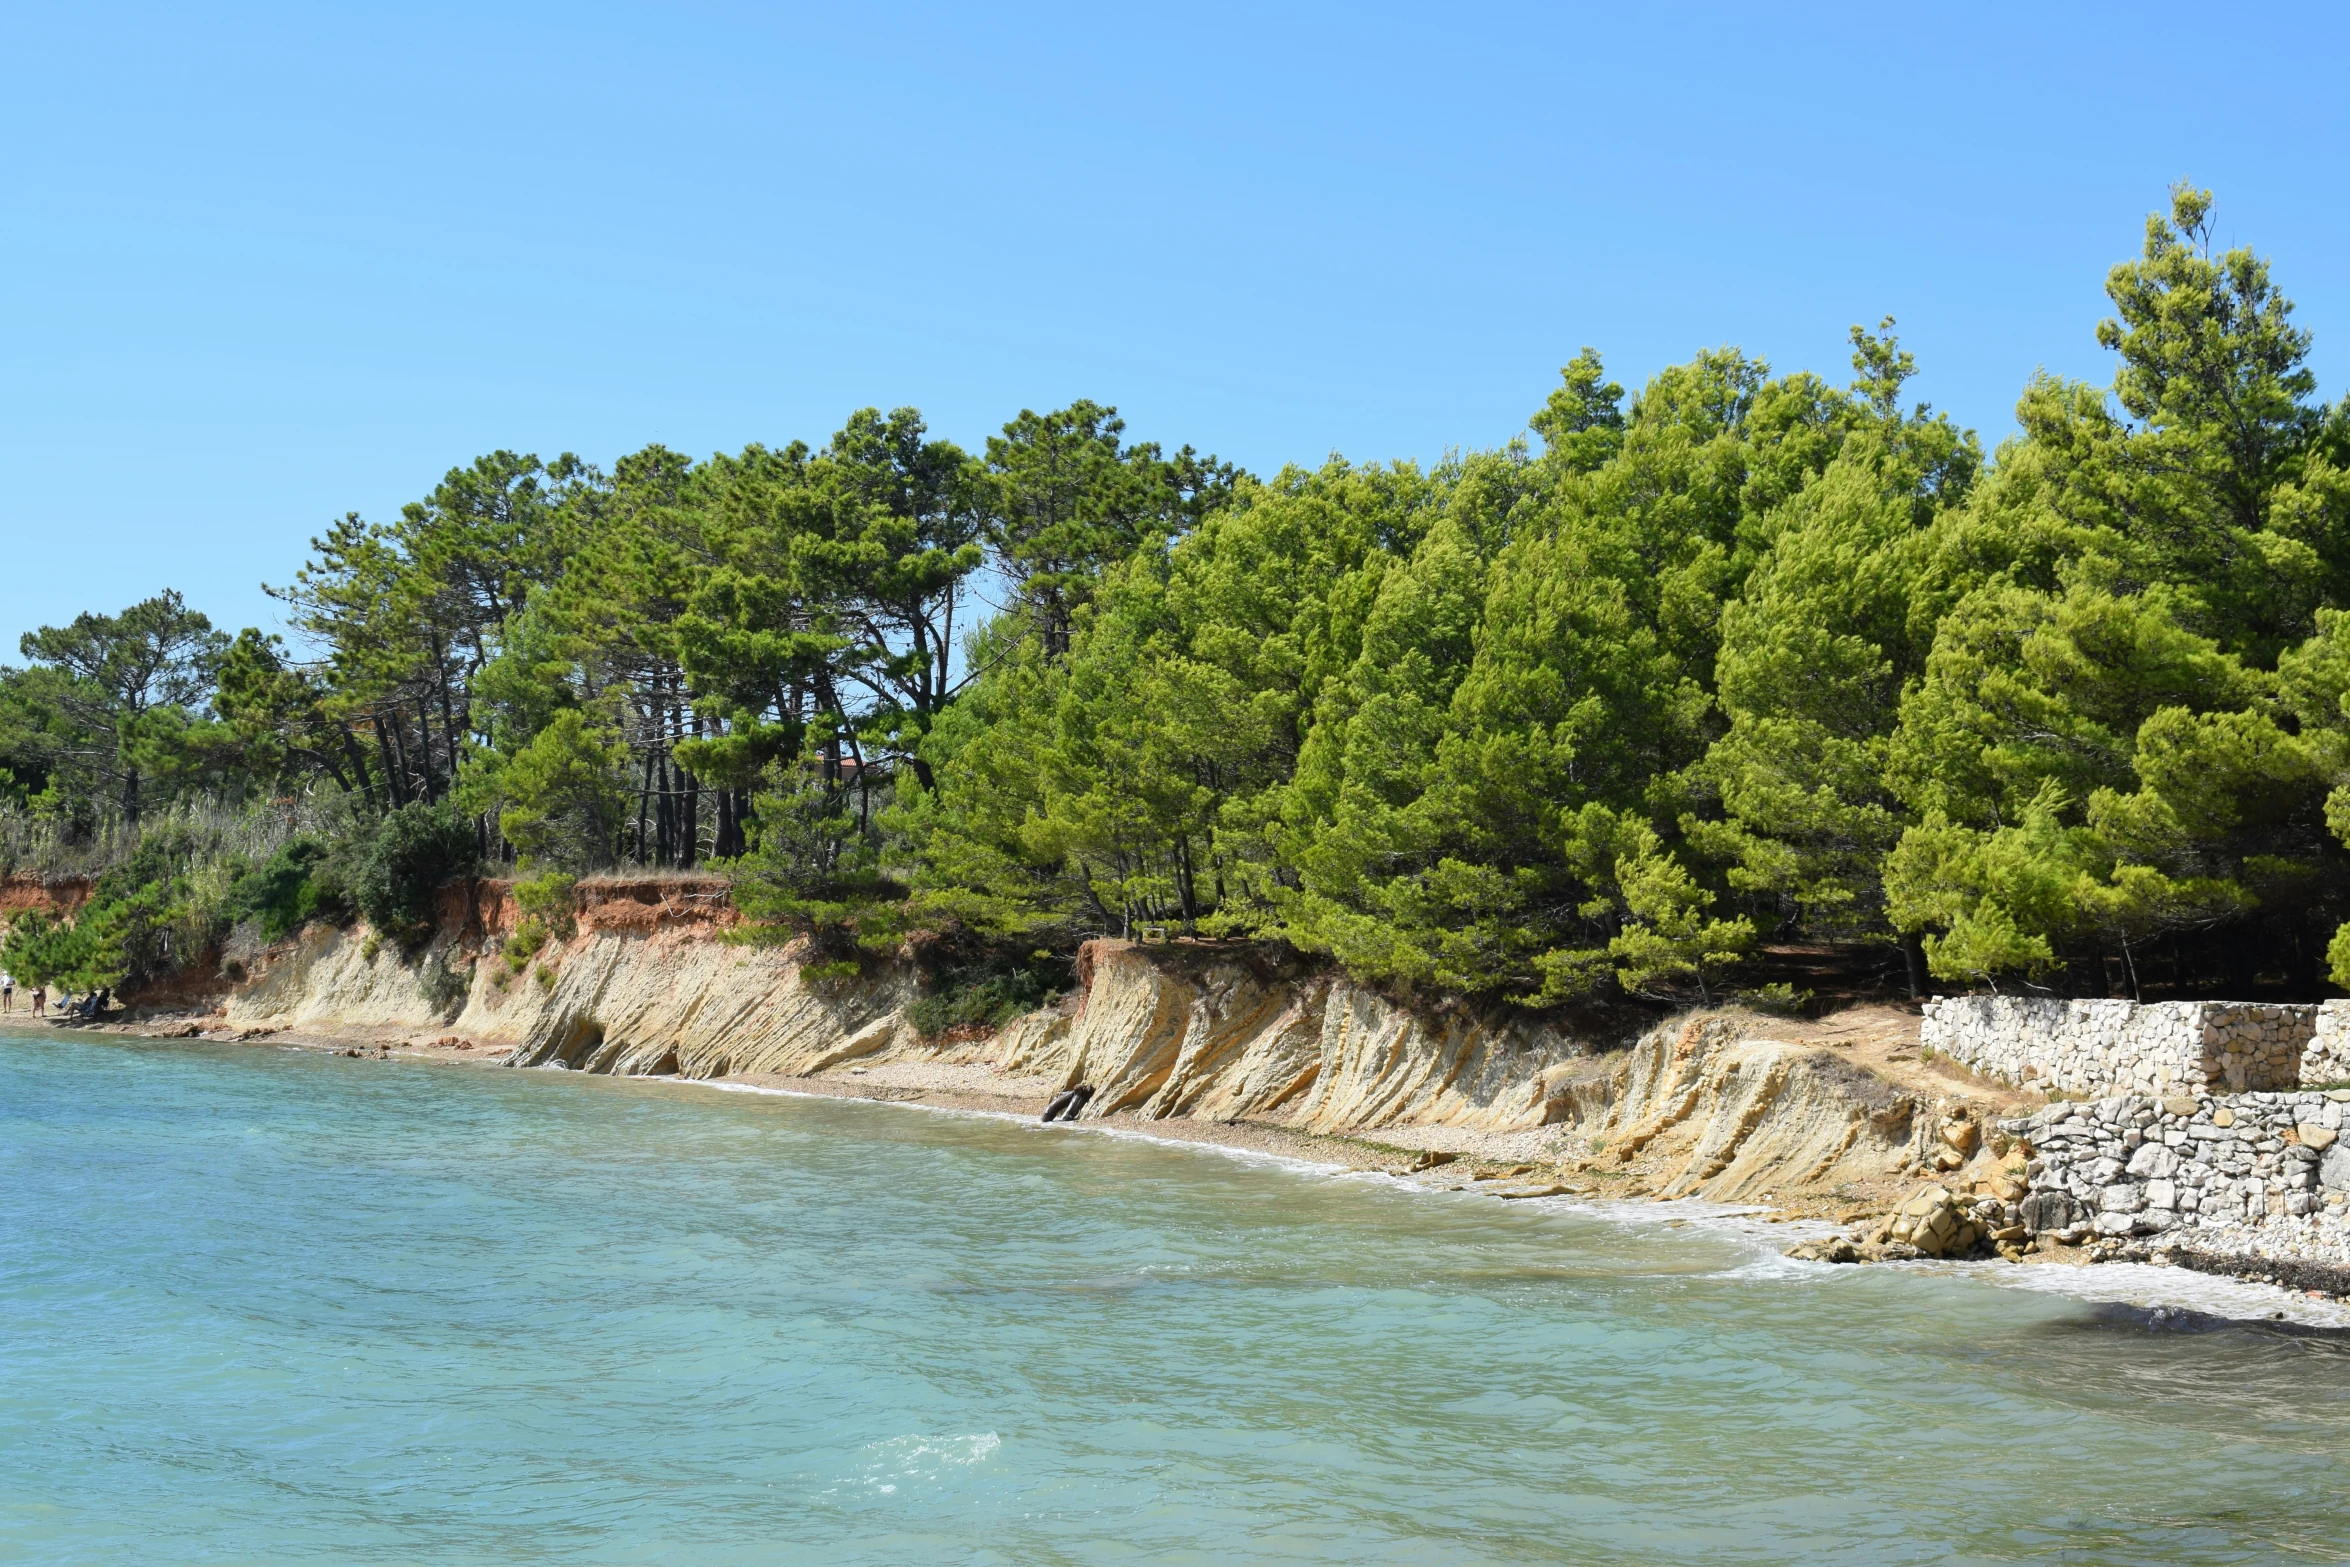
[{"x1": 18, "y1": 1017, "x2": 2350, "y2": 1332}]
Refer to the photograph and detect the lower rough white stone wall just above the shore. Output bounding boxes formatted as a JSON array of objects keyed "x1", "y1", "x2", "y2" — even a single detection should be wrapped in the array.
[{"x1": 2000, "y1": 1088, "x2": 2350, "y2": 1264}]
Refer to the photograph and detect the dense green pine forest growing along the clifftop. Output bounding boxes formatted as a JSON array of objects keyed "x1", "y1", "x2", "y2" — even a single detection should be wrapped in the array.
[{"x1": 0, "y1": 186, "x2": 2350, "y2": 1022}]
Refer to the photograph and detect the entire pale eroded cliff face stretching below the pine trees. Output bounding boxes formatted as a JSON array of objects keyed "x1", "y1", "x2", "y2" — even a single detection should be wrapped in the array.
[{"x1": 228, "y1": 925, "x2": 1990, "y2": 1201}]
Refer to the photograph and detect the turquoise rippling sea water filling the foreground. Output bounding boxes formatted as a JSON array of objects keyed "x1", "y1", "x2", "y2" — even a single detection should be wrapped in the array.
[{"x1": 0, "y1": 1034, "x2": 2350, "y2": 1567}]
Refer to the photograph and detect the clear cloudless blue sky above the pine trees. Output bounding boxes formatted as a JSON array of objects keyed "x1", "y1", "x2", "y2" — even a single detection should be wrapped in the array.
[{"x1": 0, "y1": 0, "x2": 2350, "y2": 658}]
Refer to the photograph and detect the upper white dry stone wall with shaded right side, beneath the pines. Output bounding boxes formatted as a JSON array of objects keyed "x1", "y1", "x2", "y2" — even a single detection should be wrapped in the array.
[{"x1": 1920, "y1": 996, "x2": 2312, "y2": 1095}]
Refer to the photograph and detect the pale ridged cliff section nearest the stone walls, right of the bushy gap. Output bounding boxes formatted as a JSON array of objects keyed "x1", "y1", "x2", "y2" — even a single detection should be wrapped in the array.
[{"x1": 980, "y1": 942, "x2": 1945, "y2": 1201}]
